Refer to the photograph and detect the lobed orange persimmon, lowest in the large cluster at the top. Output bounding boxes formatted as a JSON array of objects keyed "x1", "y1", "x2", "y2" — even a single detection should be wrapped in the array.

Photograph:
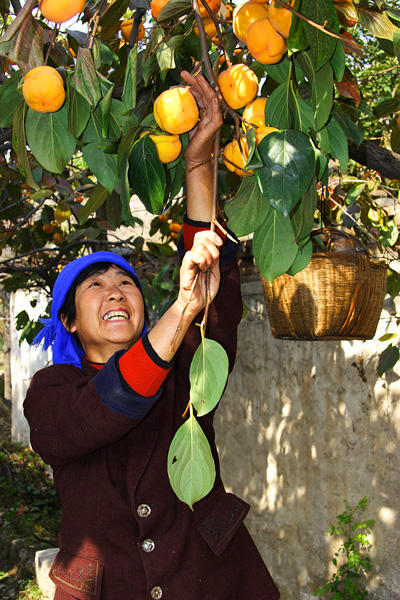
[{"x1": 246, "y1": 19, "x2": 287, "y2": 65}]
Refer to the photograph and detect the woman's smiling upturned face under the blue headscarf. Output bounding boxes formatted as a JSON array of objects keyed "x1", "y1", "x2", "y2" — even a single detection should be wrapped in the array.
[{"x1": 70, "y1": 265, "x2": 144, "y2": 363}]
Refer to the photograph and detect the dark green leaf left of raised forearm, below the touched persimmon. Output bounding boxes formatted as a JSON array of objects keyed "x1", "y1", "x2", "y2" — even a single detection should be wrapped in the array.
[{"x1": 129, "y1": 135, "x2": 165, "y2": 215}]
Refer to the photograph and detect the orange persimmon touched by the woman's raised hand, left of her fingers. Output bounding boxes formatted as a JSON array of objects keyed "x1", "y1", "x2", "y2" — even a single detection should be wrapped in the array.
[{"x1": 153, "y1": 87, "x2": 199, "y2": 134}]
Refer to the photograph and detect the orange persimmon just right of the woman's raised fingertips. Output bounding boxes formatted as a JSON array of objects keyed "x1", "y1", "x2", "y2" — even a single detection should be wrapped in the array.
[{"x1": 218, "y1": 63, "x2": 258, "y2": 109}]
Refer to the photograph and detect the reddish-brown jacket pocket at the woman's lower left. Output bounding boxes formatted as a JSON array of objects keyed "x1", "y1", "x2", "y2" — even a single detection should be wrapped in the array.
[{"x1": 49, "y1": 548, "x2": 104, "y2": 600}]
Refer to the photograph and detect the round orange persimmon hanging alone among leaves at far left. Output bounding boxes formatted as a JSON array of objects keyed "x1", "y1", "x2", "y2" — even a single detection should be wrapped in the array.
[{"x1": 22, "y1": 67, "x2": 65, "y2": 113}]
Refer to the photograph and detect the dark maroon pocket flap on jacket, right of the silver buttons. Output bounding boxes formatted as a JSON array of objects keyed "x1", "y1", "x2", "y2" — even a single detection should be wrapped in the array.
[{"x1": 195, "y1": 493, "x2": 250, "y2": 556}]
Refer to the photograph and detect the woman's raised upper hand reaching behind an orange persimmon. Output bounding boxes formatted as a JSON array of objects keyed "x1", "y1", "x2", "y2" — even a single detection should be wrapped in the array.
[{"x1": 181, "y1": 71, "x2": 222, "y2": 168}]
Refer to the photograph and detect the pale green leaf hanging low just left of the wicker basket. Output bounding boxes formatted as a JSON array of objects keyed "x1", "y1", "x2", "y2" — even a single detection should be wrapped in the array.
[{"x1": 253, "y1": 210, "x2": 297, "y2": 283}]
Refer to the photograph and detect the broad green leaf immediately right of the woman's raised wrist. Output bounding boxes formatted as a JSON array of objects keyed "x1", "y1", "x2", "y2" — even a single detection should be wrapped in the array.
[{"x1": 224, "y1": 177, "x2": 271, "y2": 237}]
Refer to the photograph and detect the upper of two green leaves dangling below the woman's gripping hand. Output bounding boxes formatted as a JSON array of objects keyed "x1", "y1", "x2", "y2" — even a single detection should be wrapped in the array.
[{"x1": 189, "y1": 333, "x2": 229, "y2": 417}]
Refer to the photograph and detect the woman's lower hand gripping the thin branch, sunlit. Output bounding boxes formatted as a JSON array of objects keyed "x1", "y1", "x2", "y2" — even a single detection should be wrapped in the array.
[{"x1": 178, "y1": 231, "x2": 223, "y2": 319}]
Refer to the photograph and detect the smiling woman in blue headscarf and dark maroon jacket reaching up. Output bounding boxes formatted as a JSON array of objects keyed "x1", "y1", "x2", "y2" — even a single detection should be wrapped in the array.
[{"x1": 25, "y1": 72, "x2": 279, "y2": 600}]
